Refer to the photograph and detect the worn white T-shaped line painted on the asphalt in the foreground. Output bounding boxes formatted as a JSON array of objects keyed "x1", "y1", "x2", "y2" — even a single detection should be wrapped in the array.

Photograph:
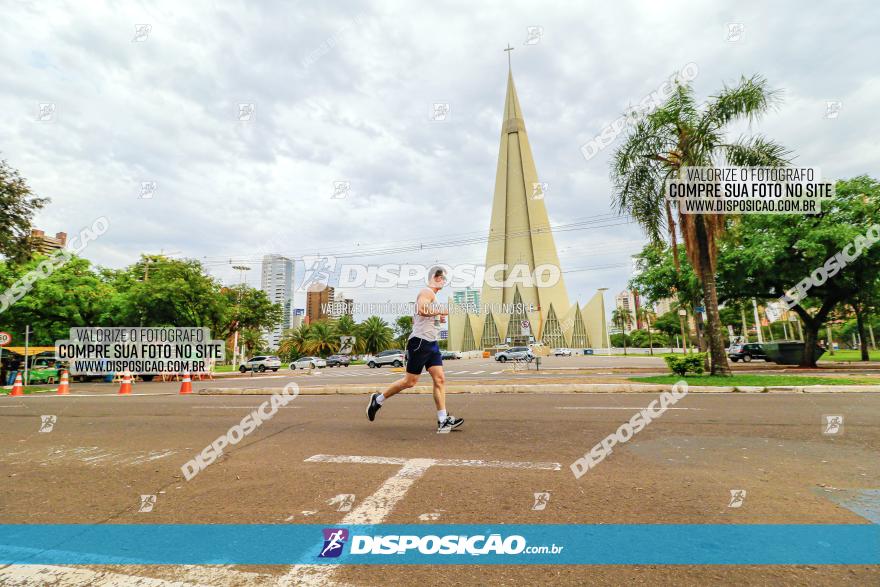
[{"x1": 278, "y1": 455, "x2": 561, "y2": 586}]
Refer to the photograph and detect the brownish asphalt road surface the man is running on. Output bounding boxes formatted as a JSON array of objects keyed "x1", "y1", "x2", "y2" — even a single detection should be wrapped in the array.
[{"x1": 0, "y1": 388, "x2": 880, "y2": 585}]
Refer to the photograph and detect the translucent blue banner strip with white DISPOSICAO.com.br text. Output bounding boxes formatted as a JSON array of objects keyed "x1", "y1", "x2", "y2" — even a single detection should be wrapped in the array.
[{"x1": 0, "y1": 524, "x2": 880, "y2": 565}]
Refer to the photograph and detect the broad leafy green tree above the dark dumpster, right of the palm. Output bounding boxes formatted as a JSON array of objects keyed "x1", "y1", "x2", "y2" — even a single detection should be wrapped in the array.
[{"x1": 718, "y1": 176, "x2": 880, "y2": 367}]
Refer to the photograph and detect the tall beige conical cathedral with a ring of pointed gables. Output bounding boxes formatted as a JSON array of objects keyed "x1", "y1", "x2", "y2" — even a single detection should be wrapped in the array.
[{"x1": 448, "y1": 60, "x2": 605, "y2": 351}]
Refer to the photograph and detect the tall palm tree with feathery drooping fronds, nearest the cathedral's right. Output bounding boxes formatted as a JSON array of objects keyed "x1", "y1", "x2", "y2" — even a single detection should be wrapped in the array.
[{"x1": 611, "y1": 76, "x2": 788, "y2": 375}]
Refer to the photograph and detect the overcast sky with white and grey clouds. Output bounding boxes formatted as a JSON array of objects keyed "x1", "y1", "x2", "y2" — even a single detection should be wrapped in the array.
[{"x1": 0, "y1": 0, "x2": 880, "y2": 322}]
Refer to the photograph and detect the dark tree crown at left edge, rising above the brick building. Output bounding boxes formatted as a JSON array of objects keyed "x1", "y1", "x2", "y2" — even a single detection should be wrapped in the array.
[{"x1": 0, "y1": 160, "x2": 49, "y2": 263}]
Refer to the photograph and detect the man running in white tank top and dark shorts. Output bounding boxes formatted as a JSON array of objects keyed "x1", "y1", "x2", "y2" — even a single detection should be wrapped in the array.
[{"x1": 367, "y1": 267, "x2": 464, "y2": 434}]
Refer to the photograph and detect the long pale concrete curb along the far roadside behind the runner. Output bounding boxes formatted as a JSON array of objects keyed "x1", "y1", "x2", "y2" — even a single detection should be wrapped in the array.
[{"x1": 198, "y1": 383, "x2": 880, "y2": 395}]
